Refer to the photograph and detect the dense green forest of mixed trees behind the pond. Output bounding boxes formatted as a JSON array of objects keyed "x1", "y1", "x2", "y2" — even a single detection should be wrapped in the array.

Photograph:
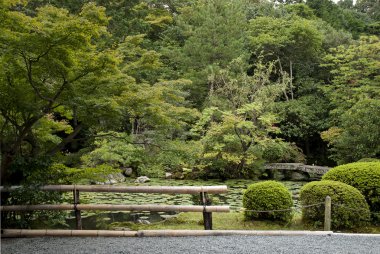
[{"x1": 0, "y1": 0, "x2": 380, "y2": 184}]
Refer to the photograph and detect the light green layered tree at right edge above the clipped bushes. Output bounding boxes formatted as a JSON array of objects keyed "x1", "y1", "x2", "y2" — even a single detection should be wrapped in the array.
[{"x1": 322, "y1": 36, "x2": 380, "y2": 163}]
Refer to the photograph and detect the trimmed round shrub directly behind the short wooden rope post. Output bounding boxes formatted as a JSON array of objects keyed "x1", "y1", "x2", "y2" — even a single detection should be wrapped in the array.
[{"x1": 300, "y1": 181, "x2": 370, "y2": 229}]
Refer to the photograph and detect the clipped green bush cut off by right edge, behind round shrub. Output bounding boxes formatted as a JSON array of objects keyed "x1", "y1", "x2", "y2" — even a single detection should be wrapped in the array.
[{"x1": 322, "y1": 161, "x2": 380, "y2": 222}]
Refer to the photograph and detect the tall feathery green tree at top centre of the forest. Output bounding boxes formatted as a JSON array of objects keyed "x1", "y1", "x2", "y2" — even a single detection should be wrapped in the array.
[{"x1": 162, "y1": 0, "x2": 246, "y2": 106}]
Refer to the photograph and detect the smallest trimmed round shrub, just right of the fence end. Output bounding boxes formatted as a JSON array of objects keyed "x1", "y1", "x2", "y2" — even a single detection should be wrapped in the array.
[{"x1": 243, "y1": 181, "x2": 293, "y2": 222}]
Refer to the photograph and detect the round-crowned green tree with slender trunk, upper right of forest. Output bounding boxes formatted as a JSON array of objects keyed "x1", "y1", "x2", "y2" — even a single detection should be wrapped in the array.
[{"x1": 248, "y1": 16, "x2": 323, "y2": 100}]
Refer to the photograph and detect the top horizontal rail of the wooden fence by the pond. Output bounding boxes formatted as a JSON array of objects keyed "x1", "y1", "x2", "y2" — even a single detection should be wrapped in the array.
[{"x1": 0, "y1": 185, "x2": 228, "y2": 194}]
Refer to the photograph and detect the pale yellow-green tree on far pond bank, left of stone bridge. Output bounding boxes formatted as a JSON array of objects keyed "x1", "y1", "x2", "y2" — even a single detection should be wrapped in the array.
[{"x1": 193, "y1": 58, "x2": 302, "y2": 177}]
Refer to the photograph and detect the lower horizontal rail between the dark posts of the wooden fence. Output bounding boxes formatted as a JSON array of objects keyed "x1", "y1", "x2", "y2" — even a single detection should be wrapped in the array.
[{"x1": 0, "y1": 204, "x2": 230, "y2": 213}]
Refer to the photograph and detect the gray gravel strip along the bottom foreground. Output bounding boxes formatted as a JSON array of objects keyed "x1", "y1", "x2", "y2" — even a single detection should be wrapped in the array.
[{"x1": 1, "y1": 235, "x2": 380, "y2": 254}]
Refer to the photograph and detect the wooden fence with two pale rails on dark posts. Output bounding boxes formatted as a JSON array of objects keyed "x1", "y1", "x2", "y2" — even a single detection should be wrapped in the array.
[{"x1": 0, "y1": 185, "x2": 230, "y2": 230}]
